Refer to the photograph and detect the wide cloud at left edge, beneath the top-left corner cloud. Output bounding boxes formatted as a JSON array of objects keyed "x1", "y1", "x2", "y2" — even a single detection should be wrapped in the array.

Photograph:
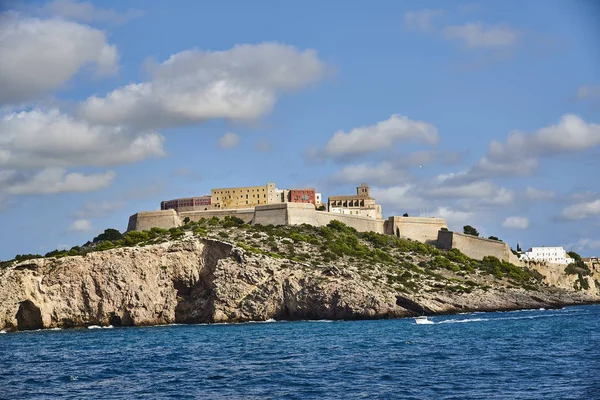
[{"x1": 0, "y1": 109, "x2": 164, "y2": 168}]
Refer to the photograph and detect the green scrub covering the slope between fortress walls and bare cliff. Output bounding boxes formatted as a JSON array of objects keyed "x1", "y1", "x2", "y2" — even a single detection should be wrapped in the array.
[{"x1": 0, "y1": 216, "x2": 541, "y2": 293}]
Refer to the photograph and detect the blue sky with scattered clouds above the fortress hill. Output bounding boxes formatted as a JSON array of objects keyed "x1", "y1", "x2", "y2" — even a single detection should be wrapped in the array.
[{"x1": 0, "y1": 0, "x2": 600, "y2": 259}]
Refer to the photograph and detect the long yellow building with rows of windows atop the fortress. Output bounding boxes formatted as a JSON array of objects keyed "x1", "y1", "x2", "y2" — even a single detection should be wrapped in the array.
[{"x1": 210, "y1": 182, "x2": 281, "y2": 209}]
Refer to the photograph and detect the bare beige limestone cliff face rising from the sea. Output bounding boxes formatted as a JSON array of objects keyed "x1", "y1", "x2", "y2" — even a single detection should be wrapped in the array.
[{"x1": 0, "y1": 238, "x2": 600, "y2": 331}]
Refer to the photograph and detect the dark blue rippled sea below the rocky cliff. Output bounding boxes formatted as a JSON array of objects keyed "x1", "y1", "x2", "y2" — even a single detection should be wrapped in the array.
[{"x1": 0, "y1": 305, "x2": 600, "y2": 399}]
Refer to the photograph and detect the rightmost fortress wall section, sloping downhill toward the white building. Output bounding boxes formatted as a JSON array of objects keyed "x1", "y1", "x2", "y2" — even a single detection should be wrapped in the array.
[{"x1": 437, "y1": 231, "x2": 510, "y2": 265}]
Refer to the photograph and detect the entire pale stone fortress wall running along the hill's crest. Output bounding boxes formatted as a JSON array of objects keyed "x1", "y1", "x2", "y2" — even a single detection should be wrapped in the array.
[{"x1": 127, "y1": 203, "x2": 521, "y2": 265}]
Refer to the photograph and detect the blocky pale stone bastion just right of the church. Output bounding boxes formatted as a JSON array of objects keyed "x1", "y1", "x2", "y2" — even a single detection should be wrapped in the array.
[{"x1": 385, "y1": 216, "x2": 448, "y2": 243}]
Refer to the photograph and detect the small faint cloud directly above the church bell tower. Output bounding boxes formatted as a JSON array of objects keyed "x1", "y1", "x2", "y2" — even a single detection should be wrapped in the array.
[{"x1": 329, "y1": 162, "x2": 407, "y2": 186}]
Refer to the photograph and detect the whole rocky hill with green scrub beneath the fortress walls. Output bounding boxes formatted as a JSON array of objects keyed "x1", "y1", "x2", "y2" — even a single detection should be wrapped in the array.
[{"x1": 0, "y1": 217, "x2": 600, "y2": 330}]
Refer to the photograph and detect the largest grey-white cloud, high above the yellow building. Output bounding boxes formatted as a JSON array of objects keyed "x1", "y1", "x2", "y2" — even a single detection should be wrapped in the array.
[{"x1": 80, "y1": 43, "x2": 326, "y2": 127}]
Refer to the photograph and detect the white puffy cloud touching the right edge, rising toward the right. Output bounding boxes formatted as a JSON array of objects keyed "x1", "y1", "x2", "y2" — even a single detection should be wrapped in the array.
[{"x1": 473, "y1": 114, "x2": 600, "y2": 175}]
